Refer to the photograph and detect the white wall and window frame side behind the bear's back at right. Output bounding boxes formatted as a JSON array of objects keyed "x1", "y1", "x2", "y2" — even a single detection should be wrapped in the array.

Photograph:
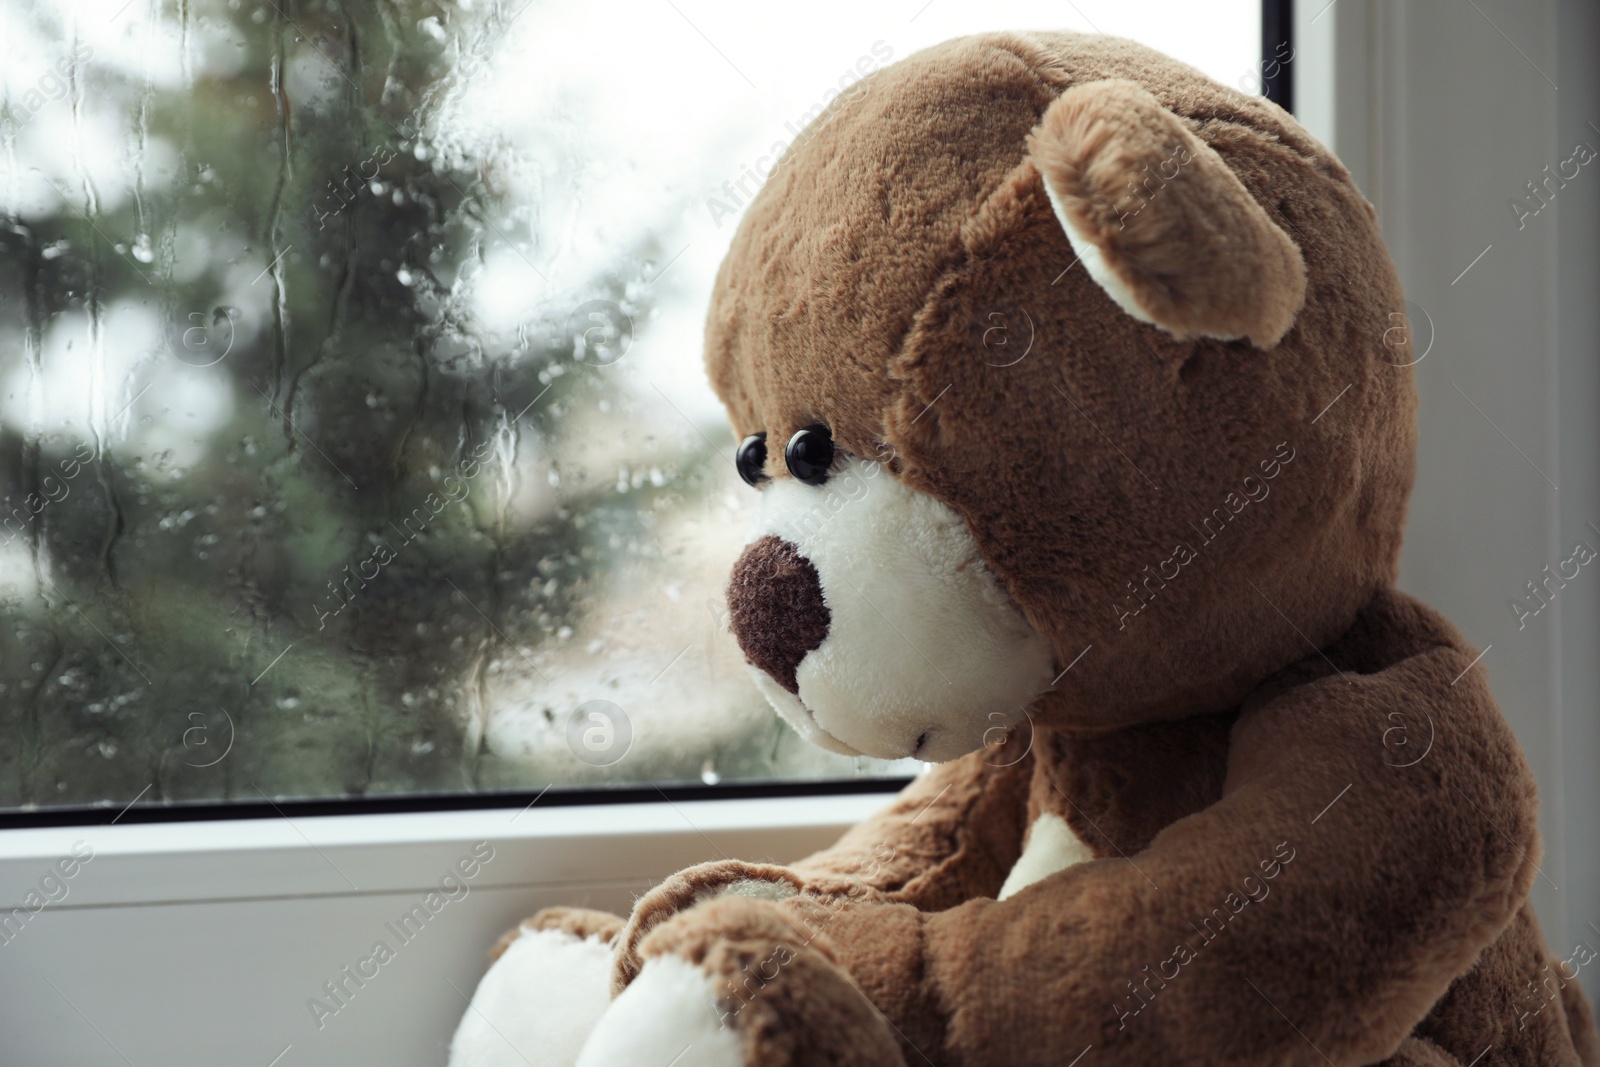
[{"x1": 1296, "y1": 0, "x2": 1600, "y2": 966}]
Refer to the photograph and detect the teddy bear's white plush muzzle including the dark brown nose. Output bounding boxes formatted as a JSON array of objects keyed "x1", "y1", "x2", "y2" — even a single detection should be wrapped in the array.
[{"x1": 728, "y1": 454, "x2": 1051, "y2": 761}]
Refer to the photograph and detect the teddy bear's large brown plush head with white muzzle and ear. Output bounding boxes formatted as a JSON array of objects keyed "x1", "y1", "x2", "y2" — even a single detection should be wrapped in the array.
[{"x1": 707, "y1": 34, "x2": 1414, "y2": 760}]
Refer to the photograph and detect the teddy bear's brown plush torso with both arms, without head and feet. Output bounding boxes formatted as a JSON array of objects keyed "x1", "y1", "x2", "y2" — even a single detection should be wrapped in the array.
[{"x1": 752, "y1": 592, "x2": 1597, "y2": 1067}]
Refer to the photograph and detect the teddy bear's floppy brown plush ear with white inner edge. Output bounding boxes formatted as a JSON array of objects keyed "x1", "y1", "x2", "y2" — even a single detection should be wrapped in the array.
[{"x1": 1027, "y1": 80, "x2": 1306, "y2": 349}]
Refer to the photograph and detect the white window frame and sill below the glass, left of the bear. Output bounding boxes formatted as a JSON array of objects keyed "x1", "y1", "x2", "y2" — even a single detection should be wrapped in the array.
[{"x1": 0, "y1": 793, "x2": 891, "y2": 1067}]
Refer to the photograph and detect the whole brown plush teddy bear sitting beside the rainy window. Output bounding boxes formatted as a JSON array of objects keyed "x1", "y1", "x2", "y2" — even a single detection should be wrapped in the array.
[{"x1": 451, "y1": 32, "x2": 1600, "y2": 1067}]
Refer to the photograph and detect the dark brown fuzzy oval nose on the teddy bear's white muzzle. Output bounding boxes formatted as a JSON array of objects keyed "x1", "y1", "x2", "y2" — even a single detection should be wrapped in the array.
[{"x1": 728, "y1": 534, "x2": 832, "y2": 696}]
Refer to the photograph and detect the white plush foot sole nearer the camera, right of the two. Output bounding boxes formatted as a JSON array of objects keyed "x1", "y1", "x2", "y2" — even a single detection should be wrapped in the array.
[{"x1": 578, "y1": 955, "x2": 746, "y2": 1067}]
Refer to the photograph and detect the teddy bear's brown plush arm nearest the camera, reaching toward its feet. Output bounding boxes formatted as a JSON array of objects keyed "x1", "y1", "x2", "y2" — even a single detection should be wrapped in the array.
[{"x1": 787, "y1": 648, "x2": 1538, "y2": 1065}]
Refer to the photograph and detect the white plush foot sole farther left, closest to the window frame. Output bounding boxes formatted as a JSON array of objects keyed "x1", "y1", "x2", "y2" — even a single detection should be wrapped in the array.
[{"x1": 450, "y1": 927, "x2": 621, "y2": 1067}]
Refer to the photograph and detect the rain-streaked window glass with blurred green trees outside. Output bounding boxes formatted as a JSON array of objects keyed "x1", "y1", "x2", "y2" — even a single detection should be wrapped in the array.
[{"x1": 0, "y1": 0, "x2": 1270, "y2": 811}]
